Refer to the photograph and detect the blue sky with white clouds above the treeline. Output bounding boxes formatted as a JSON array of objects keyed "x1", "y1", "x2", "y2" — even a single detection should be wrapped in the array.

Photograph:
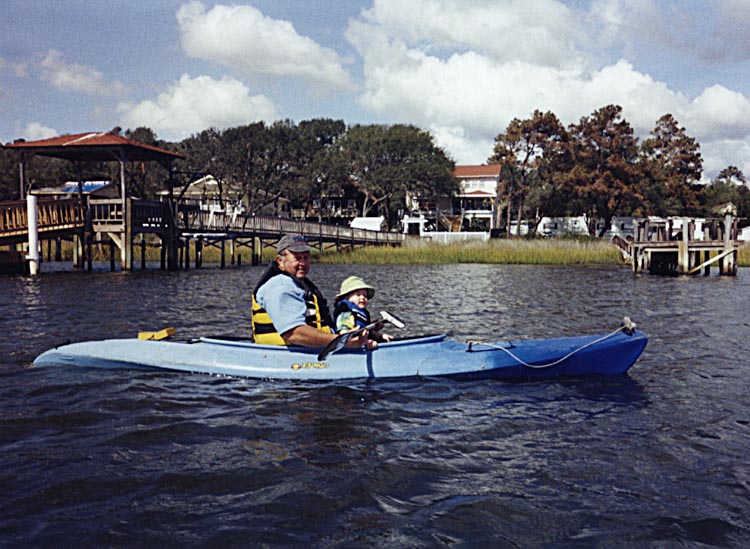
[{"x1": 0, "y1": 0, "x2": 750, "y2": 179}]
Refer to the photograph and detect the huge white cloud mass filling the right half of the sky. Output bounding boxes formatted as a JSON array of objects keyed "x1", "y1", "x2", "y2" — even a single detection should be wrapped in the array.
[{"x1": 346, "y1": 0, "x2": 750, "y2": 170}]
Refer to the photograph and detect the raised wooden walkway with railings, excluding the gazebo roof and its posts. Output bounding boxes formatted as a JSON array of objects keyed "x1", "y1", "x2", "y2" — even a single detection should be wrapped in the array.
[{"x1": 0, "y1": 198, "x2": 407, "y2": 270}]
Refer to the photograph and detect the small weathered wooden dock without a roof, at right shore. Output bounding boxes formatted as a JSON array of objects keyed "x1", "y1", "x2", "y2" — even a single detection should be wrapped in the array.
[{"x1": 613, "y1": 215, "x2": 740, "y2": 276}]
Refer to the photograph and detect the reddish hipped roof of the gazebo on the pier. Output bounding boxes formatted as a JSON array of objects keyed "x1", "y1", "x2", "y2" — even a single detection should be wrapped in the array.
[{"x1": 3, "y1": 132, "x2": 185, "y2": 162}]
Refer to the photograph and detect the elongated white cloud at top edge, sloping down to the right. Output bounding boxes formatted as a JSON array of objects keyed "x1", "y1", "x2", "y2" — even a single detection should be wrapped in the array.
[{"x1": 177, "y1": 2, "x2": 353, "y2": 90}]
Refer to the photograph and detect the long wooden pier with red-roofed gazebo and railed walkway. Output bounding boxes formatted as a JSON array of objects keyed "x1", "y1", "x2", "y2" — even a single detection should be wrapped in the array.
[{"x1": 0, "y1": 130, "x2": 407, "y2": 274}]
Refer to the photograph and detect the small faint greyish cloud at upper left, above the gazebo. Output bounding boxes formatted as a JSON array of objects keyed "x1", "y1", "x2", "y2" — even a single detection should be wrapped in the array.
[{"x1": 39, "y1": 49, "x2": 126, "y2": 95}]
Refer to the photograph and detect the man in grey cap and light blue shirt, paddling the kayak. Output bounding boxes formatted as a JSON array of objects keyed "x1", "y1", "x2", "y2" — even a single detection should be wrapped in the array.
[{"x1": 252, "y1": 234, "x2": 374, "y2": 348}]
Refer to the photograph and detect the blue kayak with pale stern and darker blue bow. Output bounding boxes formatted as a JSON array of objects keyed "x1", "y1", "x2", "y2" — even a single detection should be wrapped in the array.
[{"x1": 34, "y1": 330, "x2": 647, "y2": 380}]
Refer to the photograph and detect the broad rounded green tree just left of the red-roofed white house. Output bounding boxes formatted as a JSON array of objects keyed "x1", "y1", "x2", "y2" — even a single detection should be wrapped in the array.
[{"x1": 341, "y1": 124, "x2": 459, "y2": 228}]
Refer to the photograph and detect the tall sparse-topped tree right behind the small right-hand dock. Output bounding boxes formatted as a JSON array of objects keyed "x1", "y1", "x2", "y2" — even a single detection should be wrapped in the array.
[{"x1": 641, "y1": 114, "x2": 703, "y2": 216}]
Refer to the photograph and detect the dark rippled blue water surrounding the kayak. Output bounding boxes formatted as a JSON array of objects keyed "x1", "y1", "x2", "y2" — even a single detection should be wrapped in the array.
[{"x1": 0, "y1": 264, "x2": 750, "y2": 547}]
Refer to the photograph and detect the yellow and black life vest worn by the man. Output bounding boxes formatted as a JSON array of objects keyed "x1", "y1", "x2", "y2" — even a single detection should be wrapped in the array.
[{"x1": 252, "y1": 262, "x2": 333, "y2": 345}]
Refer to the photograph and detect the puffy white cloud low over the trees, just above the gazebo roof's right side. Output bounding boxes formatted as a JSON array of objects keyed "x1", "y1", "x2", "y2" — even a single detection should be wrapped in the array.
[{"x1": 117, "y1": 74, "x2": 279, "y2": 139}]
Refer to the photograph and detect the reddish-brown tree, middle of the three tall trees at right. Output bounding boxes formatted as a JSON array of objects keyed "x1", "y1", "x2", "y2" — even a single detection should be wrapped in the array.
[{"x1": 566, "y1": 105, "x2": 641, "y2": 236}]
